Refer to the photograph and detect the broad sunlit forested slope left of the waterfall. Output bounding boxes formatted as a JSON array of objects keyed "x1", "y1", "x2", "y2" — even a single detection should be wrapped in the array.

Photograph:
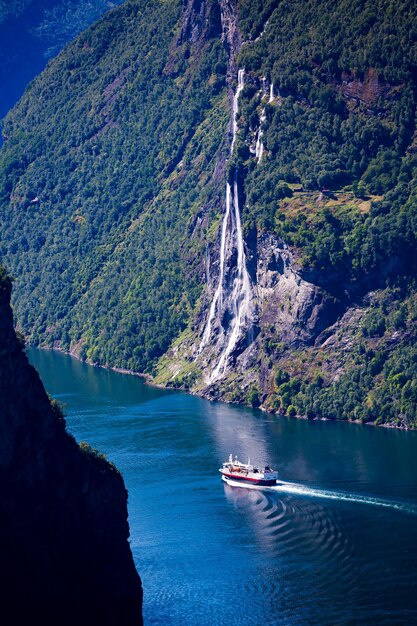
[{"x1": 0, "y1": 0, "x2": 228, "y2": 371}]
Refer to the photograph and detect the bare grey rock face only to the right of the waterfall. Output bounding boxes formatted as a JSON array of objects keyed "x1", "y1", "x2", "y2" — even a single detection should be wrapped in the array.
[{"x1": 196, "y1": 234, "x2": 340, "y2": 401}]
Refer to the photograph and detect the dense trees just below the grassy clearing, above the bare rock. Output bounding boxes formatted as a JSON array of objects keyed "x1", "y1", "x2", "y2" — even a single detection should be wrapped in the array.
[{"x1": 275, "y1": 172, "x2": 417, "y2": 287}]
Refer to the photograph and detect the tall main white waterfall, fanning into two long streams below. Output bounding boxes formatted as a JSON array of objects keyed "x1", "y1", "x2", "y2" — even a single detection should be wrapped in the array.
[{"x1": 198, "y1": 69, "x2": 252, "y2": 382}]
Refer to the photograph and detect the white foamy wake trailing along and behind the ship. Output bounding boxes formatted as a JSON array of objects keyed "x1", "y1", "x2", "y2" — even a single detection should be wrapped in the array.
[{"x1": 222, "y1": 477, "x2": 417, "y2": 515}]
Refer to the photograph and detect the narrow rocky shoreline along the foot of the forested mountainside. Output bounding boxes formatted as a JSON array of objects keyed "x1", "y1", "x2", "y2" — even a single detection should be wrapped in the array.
[{"x1": 26, "y1": 344, "x2": 417, "y2": 432}]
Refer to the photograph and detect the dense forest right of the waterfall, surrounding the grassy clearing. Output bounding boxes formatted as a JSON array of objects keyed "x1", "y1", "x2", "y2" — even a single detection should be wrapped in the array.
[{"x1": 240, "y1": 0, "x2": 417, "y2": 280}]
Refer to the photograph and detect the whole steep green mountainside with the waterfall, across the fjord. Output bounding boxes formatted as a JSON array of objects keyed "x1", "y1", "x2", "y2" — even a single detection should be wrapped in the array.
[{"x1": 0, "y1": 0, "x2": 417, "y2": 427}]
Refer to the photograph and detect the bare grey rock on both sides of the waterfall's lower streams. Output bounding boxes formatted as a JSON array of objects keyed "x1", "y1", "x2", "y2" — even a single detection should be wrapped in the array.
[{"x1": 157, "y1": 233, "x2": 343, "y2": 402}]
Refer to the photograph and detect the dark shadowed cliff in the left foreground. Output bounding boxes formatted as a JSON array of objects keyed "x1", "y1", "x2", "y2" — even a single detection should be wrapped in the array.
[{"x1": 0, "y1": 268, "x2": 142, "y2": 625}]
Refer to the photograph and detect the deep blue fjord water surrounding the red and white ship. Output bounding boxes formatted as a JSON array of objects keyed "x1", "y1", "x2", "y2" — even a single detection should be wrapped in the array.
[{"x1": 29, "y1": 349, "x2": 417, "y2": 626}]
